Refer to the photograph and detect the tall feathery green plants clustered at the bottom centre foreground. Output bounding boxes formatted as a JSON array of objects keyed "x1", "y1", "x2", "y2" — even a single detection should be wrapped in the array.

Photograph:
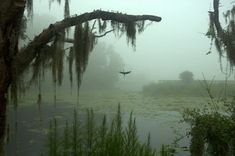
[{"x1": 46, "y1": 105, "x2": 173, "y2": 156}]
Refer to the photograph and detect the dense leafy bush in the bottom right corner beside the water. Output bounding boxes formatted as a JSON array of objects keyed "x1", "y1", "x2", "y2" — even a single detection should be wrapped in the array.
[{"x1": 183, "y1": 81, "x2": 235, "y2": 156}]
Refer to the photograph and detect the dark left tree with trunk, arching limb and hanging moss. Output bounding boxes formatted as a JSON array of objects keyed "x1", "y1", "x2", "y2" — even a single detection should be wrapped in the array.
[{"x1": 0, "y1": 0, "x2": 161, "y2": 155}]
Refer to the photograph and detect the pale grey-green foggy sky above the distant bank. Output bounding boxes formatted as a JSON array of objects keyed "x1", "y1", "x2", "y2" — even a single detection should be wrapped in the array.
[{"x1": 34, "y1": 0, "x2": 234, "y2": 81}]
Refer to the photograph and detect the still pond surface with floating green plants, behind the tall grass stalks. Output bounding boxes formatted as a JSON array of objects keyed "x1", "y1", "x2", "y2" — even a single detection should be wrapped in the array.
[{"x1": 7, "y1": 92, "x2": 196, "y2": 156}]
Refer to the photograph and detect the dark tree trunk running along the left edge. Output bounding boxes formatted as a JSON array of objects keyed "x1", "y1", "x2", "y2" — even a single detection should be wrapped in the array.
[{"x1": 0, "y1": 0, "x2": 25, "y2": 156}]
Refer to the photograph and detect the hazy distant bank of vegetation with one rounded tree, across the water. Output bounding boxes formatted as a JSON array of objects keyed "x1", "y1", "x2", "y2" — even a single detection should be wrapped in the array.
[{"x1": 142, "y1": 71, "x2": 235, "y2": 97}]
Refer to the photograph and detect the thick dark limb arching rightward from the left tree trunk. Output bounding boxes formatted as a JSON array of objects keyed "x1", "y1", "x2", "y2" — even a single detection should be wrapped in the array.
[{"x1": 14, "y1": 10, "x2": 161, "y2": 73}]
